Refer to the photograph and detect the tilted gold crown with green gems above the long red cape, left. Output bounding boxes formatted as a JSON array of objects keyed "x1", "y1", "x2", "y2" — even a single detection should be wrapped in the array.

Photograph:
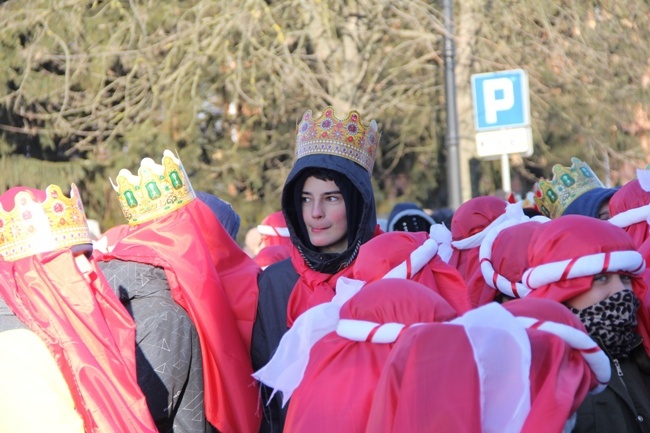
[{"x1": 111, "y1": 150, "x2": 196, "y2": 226}]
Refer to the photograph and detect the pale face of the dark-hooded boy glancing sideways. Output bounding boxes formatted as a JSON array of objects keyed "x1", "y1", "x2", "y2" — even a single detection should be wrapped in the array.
[{"x1": 302, "y1": 176, "x2": 348, "y2": 253}]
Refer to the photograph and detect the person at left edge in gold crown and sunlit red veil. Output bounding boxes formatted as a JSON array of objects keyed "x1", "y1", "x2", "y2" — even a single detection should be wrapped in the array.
[{"x1": 0, "y1": 184, "x2": 158, "y2": 433}]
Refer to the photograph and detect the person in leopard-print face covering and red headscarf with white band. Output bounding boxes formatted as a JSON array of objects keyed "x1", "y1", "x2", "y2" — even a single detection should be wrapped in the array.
[{"x1": 522, "y1": 215, "x2": 650, "y2": 433}]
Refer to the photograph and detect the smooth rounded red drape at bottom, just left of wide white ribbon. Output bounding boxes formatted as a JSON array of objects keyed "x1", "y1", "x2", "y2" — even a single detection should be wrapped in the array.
[{"x1": 366, "y1": 323, "x2": 482, "y2": 433}]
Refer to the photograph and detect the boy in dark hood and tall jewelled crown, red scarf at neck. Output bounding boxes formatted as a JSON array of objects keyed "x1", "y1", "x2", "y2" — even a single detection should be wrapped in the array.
[{"x1": 251, "y1": 107, "x2": 380, "y2": 432}]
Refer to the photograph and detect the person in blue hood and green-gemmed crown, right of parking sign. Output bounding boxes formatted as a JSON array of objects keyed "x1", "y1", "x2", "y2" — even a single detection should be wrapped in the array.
[{"x1": 534, "y1": 157, "x2": 618, "y2": 220}]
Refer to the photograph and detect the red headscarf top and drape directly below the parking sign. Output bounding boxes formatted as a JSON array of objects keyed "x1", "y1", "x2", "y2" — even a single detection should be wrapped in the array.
[{"x1": 449, "y1": 196, "x2": 508, "y2": 307}]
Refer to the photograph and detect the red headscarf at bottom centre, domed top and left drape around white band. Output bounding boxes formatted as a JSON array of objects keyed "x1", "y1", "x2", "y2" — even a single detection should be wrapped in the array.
[{"x1": 284, "y1": 279, "x2": 456, "y2": 433}]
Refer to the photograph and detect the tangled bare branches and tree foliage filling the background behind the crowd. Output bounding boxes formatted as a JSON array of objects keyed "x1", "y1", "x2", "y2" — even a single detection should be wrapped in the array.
[{"x1": 0, "y1": 0, "x2": 650, "y2": 233}]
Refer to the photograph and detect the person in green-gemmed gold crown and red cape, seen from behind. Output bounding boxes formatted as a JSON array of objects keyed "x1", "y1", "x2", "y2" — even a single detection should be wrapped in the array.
[{"x1": 96, "y1": 150, "x2": 260, "y2": 433}]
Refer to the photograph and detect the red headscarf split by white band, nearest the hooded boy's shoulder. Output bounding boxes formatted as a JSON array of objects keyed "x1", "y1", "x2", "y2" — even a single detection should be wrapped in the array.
[{"x1": 352, "y1": 231, "x2": 471, "y2": 314}]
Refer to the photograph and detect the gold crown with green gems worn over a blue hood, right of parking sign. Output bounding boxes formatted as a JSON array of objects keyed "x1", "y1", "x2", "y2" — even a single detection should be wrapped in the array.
[{"x1": 535, "y1": 157, "x2": 605, "y2": 219}]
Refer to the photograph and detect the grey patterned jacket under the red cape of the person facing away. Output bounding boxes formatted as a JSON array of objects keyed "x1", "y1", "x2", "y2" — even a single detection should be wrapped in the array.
[{"x1": 99, "y1": 259, "x2": 217, "y2": 433}]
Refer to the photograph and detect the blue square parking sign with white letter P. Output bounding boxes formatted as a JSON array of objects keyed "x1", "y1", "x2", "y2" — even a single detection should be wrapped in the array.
[{"x1": 472, "y1": 69, "x2": 530, "y2": 131}]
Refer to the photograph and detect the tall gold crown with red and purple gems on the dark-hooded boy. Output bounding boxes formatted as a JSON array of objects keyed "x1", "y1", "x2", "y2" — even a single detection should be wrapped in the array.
[{"x1": 295, "y1": 107, "x2": 380, "y2": 173}]
